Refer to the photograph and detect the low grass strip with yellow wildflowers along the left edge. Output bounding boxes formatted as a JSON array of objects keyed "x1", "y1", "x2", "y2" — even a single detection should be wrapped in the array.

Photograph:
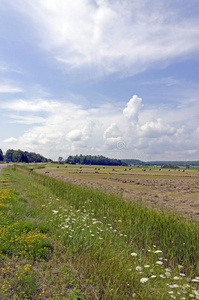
[{"x1": 0, "y1": 172, "x2": 93, "y2": 299}]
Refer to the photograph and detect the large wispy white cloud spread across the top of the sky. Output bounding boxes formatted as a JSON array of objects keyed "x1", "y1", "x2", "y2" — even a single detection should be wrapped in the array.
[{"x1": 10, "y1": 0, "x2": 199, "y2": 76}]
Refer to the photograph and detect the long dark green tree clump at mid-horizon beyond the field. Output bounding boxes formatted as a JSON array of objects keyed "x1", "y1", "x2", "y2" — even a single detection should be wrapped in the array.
[{"x1": 65, "y1": 154, "x2": 127, "y2": 166}]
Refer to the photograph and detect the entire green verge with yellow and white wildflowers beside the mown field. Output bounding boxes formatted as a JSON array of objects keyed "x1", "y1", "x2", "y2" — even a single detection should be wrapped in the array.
[{"x1": 0, "y1": 165, "x2": 199, "y2": 300}]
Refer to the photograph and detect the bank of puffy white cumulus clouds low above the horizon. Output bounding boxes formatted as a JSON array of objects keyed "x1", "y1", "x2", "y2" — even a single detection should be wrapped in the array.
[{"x1": 2, "y1": 95, "x2": 199, "y2": 160}]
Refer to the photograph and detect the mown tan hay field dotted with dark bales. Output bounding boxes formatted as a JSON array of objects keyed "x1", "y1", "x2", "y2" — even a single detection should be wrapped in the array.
[{"x1": 37, "y1": 165, "x2": 199, "y2": 219}]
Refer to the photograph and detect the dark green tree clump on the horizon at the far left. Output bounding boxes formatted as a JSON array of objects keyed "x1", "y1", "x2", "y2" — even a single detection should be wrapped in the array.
[{"x1": 0, "y1": 149, "x2": 51, "y2": 163}]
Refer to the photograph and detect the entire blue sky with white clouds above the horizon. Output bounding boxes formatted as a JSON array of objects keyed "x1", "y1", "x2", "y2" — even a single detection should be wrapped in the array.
[{"x1": 0, "y1": 0, "x2": 199, "y2": 161}]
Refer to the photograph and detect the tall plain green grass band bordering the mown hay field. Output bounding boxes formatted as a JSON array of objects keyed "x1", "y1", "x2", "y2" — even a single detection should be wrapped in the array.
[{"x1": 22, "y1": 165, "x2": 199, "y2": 276}]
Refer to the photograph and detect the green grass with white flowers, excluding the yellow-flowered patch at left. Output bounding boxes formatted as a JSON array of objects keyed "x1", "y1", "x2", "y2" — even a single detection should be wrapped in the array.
[{"x1": 2, "y1": 167, "x2": 199, "y2": 300}]
